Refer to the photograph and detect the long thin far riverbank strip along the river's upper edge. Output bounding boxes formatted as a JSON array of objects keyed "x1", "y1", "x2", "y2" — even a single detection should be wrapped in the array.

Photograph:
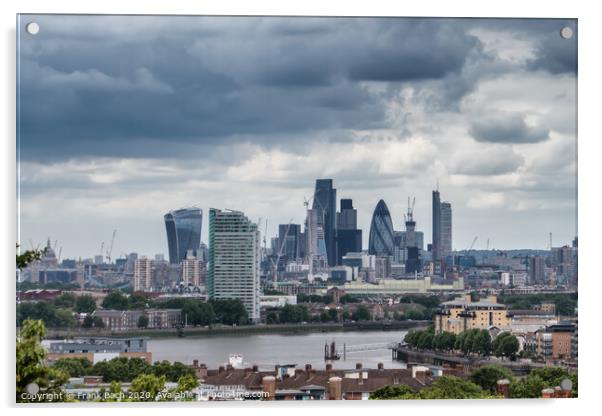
[{"x1": 46, "y1": 321, "x2": 431, "y2": 339}]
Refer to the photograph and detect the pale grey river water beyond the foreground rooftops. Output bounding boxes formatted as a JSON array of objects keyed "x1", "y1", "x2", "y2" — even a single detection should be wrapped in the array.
[{"x1": 147, "y1": 330, "x2": 407, "y2": 369}]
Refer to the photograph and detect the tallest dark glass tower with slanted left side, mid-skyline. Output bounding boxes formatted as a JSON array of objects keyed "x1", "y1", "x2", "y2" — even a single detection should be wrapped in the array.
[{"x1": 312, "y1": 179, "x2": 337, "y2": 267}]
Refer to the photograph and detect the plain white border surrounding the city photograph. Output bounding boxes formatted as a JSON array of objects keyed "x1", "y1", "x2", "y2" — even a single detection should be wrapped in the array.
[{"x1": 0, "y1": 0, "x2": 602, "y2": 416}]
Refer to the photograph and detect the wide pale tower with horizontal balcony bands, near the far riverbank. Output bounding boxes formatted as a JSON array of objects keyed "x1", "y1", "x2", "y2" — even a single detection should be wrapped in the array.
[{"x1": 207, "y1": 208, "x2": 261, "y2": 322}]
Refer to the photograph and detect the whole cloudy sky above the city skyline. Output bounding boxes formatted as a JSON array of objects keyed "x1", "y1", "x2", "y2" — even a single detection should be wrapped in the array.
[{"x1": 18, "y1": 15, "x2": 577, "y2": 258}]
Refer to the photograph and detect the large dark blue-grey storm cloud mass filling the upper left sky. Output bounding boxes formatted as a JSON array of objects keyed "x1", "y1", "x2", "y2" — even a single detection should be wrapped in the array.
[{"x1": 20, "y1": 16, "x2": 479, "y2": 159}]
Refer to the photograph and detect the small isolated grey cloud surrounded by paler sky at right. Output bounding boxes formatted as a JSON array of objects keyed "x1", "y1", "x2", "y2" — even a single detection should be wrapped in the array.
[{"x1": 469, "y1": 114, "x2": 550, "y2": 143}]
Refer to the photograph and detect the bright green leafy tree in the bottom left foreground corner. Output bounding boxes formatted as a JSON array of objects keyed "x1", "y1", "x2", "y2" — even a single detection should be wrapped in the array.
[{"x1": 16, "y1": 319, "x2": 68, "y2": 402}]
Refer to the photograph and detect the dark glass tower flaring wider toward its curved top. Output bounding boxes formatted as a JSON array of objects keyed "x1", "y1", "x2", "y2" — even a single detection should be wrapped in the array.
[{"x1": 164, "y1": 207, "x2": 203, "y2": 264}]
